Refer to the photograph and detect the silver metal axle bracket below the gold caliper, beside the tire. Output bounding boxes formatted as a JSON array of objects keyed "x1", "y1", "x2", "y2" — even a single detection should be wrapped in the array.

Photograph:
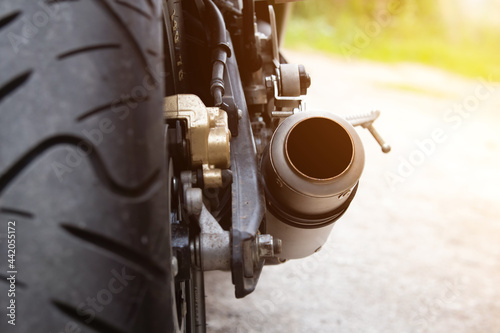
[{"x1": 199, "y1": 205, "x2": 231, "y2": 271}]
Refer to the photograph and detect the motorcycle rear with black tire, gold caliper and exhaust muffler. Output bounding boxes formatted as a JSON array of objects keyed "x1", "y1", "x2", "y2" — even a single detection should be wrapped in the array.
[{"x1": 0, "y1": 0, "x2": 390, "y2": 332}]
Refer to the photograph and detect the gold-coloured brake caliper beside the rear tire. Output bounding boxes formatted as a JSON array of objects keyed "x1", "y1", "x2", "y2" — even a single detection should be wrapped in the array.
[{"x1": 164, "y1": 95, "x2": 231, "y2": 187}]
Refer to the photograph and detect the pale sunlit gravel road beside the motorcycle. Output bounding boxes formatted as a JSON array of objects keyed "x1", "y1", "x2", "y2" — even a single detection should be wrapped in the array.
[{"x1": 202, "y1": 52, "x2": 500, "y2": 333}]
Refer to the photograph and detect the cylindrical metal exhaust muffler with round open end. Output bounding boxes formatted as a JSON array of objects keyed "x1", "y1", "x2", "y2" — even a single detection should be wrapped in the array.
[{"x1": 261, "y1": 111, "x2": 365, "y2": 259}]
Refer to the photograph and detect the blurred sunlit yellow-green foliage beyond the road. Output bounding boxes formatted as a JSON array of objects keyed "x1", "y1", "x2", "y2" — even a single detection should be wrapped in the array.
[{"x1": 285, "y1": 0, "x2": 500, "y2": 81}]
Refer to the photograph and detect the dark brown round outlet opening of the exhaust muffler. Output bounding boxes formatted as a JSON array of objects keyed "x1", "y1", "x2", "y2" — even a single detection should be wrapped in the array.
[{"x1": 285, "y1": 117, "x2": 354, "y2": 180}]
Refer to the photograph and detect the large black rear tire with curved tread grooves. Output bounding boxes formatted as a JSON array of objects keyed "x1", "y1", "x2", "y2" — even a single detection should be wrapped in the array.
[{"x1": 0, "y1": 0, "x2": 175, "y2": 332}]
